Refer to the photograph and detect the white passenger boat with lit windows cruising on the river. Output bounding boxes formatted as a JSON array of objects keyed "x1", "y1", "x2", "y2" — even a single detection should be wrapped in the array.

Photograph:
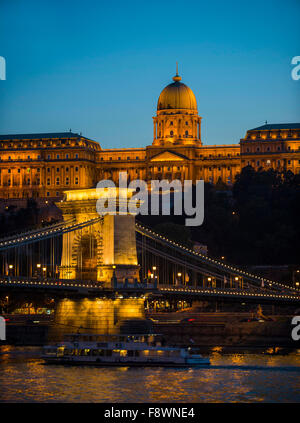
[{"x1": 42, "y1": 334, "x2": 210, "y2": 367}]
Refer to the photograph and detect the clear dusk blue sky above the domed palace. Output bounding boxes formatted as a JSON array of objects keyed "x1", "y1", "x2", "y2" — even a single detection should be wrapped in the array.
[{"x1": 0, "y1": 0, "x2": 300, "y2": 148}]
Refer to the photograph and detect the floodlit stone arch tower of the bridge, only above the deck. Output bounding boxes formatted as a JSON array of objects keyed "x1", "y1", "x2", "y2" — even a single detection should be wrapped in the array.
[{"x1": 57, "y1": 188, "x2": 139, "y2": 286}]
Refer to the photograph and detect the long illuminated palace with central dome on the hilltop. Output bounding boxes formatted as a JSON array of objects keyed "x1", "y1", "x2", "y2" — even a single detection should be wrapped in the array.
[{"x1": 0, "y1": 74, "x2": 300, "y2": 199}]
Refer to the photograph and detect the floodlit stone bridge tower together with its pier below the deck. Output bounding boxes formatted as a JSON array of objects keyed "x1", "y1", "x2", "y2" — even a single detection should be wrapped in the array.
[{"x1": 49, "y1": 188, "x2": 149, "y2": 340}]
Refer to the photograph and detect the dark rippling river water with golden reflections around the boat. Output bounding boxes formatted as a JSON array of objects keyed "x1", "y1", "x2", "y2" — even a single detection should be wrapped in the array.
[{"x1": 0, "y1": 346, "x2": 300, "y2": 403}]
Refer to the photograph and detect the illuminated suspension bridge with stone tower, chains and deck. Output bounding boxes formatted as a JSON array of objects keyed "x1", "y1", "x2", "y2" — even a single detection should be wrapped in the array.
[{"x1": 0, "y1": 189, "x2": 300, "y2": 338}]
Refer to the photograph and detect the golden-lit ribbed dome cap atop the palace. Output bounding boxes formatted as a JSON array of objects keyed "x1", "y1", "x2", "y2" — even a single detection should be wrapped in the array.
[{"x1": 157, "y1": 74, "x2": 197, "y2": 110}]
